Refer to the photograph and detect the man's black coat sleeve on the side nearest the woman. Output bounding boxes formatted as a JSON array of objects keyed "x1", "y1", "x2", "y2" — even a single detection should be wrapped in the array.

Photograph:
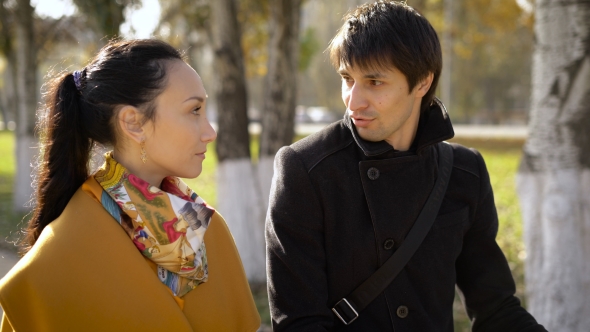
[{"x1": 266, "y1": 147, "x2": 333, "y2": 332}]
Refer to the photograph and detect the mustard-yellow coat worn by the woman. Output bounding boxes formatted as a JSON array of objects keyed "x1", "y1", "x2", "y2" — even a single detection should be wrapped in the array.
[{"x1": 0, "y1": 177, "x2": 260, "y2": 332}]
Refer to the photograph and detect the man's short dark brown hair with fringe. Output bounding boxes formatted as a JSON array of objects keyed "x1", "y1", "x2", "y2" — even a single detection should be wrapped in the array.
[{"x1": 328, "y1": 1, "x2": 442, "y2": 110}]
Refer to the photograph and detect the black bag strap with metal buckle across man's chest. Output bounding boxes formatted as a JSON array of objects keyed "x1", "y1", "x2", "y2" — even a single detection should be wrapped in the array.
[{"x1": 332, "y1": 142, "x2": 453, "y2": 325}]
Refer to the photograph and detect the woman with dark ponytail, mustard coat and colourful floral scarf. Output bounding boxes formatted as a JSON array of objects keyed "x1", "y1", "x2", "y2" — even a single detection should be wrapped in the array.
[{"x1": 0, "y1": 40, "x2": 260, "y2": 331}]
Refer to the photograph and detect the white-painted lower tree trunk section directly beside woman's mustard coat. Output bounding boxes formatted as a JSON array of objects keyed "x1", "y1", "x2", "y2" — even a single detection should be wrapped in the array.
[{"x1": 217, "y1": 158, "x2": 268, "y2": 283}]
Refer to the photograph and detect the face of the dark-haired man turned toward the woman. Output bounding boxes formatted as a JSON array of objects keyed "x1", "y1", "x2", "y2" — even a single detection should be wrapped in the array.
[{"x1": 338, "y1": 66, "x2": 430, "y2": 149}]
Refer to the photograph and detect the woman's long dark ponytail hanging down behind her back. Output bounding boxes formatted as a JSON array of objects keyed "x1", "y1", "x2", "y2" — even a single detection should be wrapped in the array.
[{"x1": 22, "y1": 74, "x2": 92, "y2": 252}]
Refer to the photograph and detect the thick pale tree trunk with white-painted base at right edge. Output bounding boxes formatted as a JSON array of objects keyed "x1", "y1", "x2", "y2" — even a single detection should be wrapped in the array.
[{"x1": 517, "y1": 0, "x2": 590, "y2": 332}]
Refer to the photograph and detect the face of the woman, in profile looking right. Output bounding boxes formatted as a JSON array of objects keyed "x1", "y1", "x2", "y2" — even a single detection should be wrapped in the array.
[{"x1": 143, "y1": 60, "x2": 217, "y2": 182}]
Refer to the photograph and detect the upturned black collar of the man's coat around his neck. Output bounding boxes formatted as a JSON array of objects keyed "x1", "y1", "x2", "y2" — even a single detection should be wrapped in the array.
[{"x1": 344, "y1": 97, "x2": 455, "y2": 157}]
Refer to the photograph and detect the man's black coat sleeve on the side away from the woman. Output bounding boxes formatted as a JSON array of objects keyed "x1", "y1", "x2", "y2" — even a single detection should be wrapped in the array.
[{"x1": 456, "y1": 151, "x2": 546, "y2": 332}]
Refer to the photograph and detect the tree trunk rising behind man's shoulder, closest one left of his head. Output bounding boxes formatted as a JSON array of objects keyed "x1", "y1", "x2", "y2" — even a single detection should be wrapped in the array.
[{"x1": 258, "y1": 0, "x2": 301, "y2": 211}]
